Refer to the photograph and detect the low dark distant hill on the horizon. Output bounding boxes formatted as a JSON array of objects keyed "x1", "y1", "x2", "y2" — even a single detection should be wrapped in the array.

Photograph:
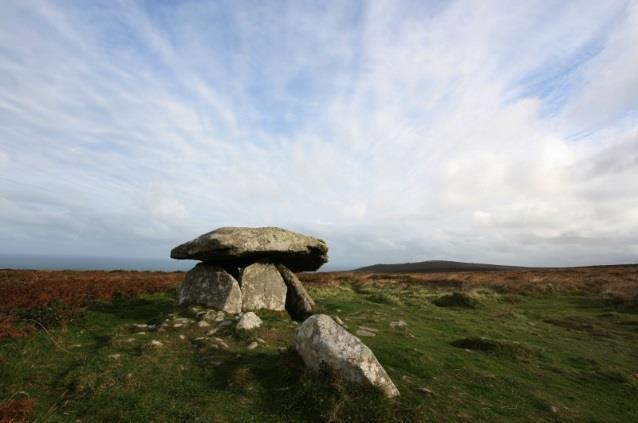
[{"x1": 353, "y1": 260, "x2": 526, "y2": 273}]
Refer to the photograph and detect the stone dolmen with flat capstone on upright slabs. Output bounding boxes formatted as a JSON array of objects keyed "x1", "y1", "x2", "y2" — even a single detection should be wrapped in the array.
[{"x1": 171, "y1": 227, "x2": 328, "y2": 321}]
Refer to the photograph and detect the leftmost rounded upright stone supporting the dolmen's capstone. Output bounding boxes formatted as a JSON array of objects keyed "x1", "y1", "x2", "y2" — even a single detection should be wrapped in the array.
[{"x1": 177, "y1": 263, "x2": 242, "y2": 313}]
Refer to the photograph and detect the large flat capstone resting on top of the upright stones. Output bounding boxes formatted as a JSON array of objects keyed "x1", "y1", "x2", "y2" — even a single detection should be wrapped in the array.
[{"x1": 171, "y1": 227, "x2": 328, "y2": 272}]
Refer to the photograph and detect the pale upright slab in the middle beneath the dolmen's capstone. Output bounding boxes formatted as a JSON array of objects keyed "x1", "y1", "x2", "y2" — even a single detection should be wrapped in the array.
[{"x1": 240, "y1": 261, "x2": 287, "y2": 311}]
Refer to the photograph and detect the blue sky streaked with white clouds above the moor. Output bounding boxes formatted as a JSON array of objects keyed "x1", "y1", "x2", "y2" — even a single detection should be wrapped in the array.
[{"x1": 0, "y1": 1, "x2": 638, "y2": 268}]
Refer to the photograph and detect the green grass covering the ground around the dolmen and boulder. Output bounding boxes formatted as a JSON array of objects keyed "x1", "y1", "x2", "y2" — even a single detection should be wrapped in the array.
[{"x1": 0, "y1": 284, "x2": 638, "y2": 422}]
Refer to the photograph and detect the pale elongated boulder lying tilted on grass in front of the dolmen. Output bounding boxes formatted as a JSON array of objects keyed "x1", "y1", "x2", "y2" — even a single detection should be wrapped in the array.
[{"x1": 295, "y1": 314, "x2": 399, "y2": 397}]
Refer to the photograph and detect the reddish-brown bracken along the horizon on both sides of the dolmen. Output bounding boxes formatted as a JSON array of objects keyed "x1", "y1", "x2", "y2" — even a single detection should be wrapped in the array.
[{"x1": 0, "y1": 266, "x2": 638, "y2": 339}]
